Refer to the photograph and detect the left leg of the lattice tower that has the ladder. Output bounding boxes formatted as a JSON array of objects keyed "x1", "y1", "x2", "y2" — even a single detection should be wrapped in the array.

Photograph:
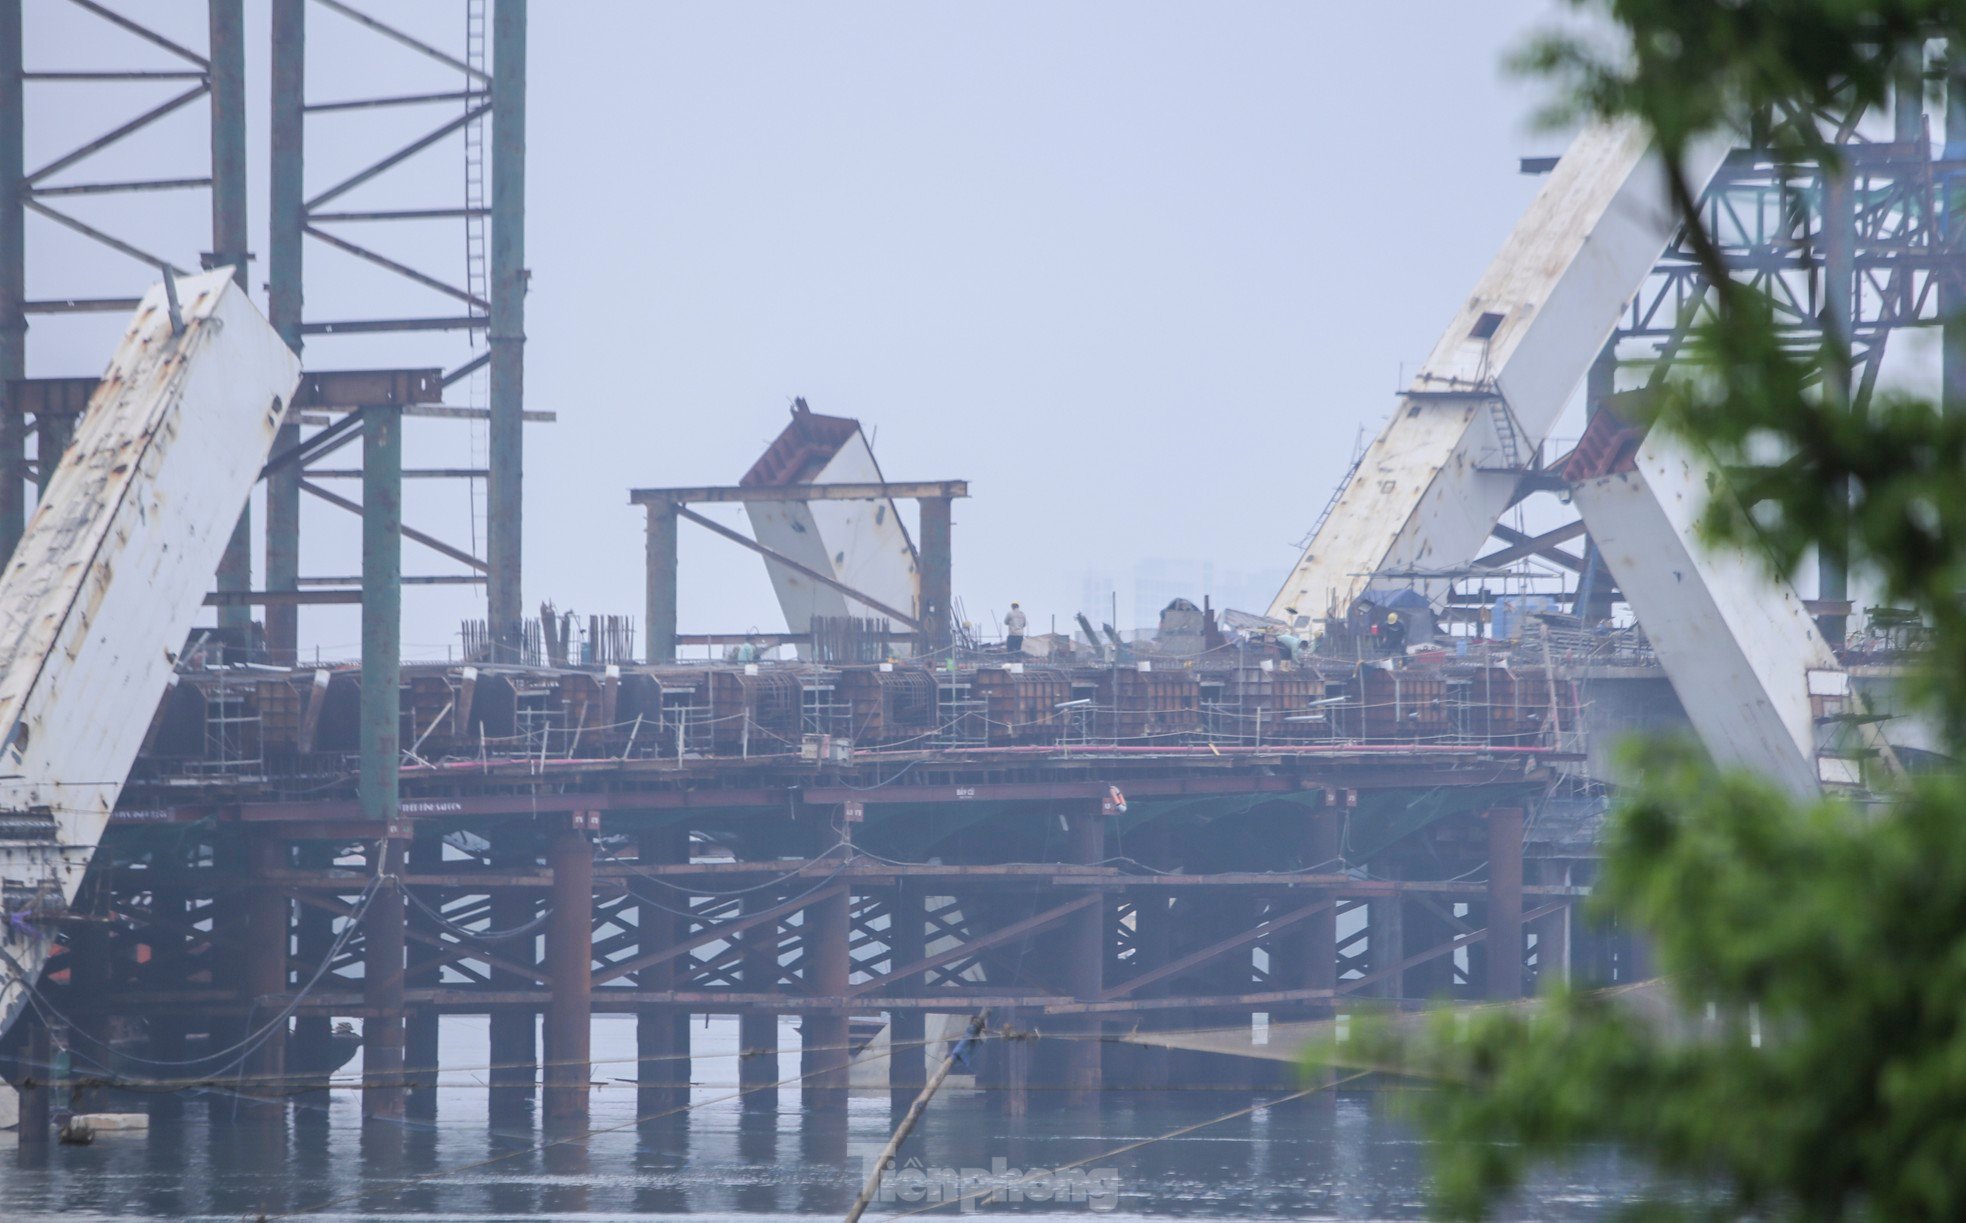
[{"x1": 265, "y1": 0, "x2": 307, "y2": 665}]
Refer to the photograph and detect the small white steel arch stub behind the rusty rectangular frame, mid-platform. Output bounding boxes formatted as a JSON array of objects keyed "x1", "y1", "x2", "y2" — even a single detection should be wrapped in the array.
[{"x1": 745, "y1": 429, "x2": 920, "y2": 653}]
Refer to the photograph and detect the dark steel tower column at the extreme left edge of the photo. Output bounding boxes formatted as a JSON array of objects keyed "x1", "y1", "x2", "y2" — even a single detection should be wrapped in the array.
[{"x1": 0, "y1": 0, "x2": 28, "y2": 562}]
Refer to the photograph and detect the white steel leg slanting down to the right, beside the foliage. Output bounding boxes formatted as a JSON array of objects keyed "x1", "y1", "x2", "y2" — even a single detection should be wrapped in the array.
[{"x1": 1573, "y1": 431, "x2": 1840, "y2": 794}]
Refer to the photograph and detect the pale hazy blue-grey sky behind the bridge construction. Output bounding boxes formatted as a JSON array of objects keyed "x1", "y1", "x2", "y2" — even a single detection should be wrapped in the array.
[{"x1": 28, "y1": 0, "x2": 1563, "y2": 657}]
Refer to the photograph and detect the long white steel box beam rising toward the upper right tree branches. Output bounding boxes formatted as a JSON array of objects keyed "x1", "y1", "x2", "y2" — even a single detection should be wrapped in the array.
[{"x1": 1270, "y1": 124, "x2": 1724, "y2": 627}]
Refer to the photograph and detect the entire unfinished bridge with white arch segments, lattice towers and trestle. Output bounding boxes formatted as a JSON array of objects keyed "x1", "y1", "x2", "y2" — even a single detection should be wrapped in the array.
[{"x1": 0, "y1": 0, "x2": 1942, "y2": 1140}]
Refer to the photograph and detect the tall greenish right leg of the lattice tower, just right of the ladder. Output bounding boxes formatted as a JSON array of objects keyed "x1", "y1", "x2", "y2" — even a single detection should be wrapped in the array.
[{"x1": 486, "y1": 0, "x2": 525, "y2": 661}]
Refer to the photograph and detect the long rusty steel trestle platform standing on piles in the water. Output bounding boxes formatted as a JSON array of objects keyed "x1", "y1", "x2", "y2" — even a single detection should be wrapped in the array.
[{"x1": 39, "y1": 659, "x2": 1612, "y2": 1119}]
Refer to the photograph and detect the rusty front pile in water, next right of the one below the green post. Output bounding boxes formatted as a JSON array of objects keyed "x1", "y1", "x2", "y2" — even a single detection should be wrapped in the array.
[{"x1": 547, "y1": 812, "x2": 594, "y2": 1121}]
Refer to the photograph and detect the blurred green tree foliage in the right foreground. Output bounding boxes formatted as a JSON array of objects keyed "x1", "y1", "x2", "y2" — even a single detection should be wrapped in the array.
[{"x1": 1347, "y1": 0, "x2": 1966, "y2": 1219}]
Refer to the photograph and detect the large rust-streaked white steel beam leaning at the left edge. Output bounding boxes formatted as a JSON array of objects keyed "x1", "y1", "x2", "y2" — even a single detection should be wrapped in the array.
[{"x1": 0, "y1": 269, "x2": 301, "y2": 1026}]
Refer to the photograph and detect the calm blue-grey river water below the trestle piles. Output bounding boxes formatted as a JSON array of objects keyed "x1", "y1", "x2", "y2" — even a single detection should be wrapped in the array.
[{"x1": 0, "y1": 1017, "x2": 1644, "y2": 1221}]
